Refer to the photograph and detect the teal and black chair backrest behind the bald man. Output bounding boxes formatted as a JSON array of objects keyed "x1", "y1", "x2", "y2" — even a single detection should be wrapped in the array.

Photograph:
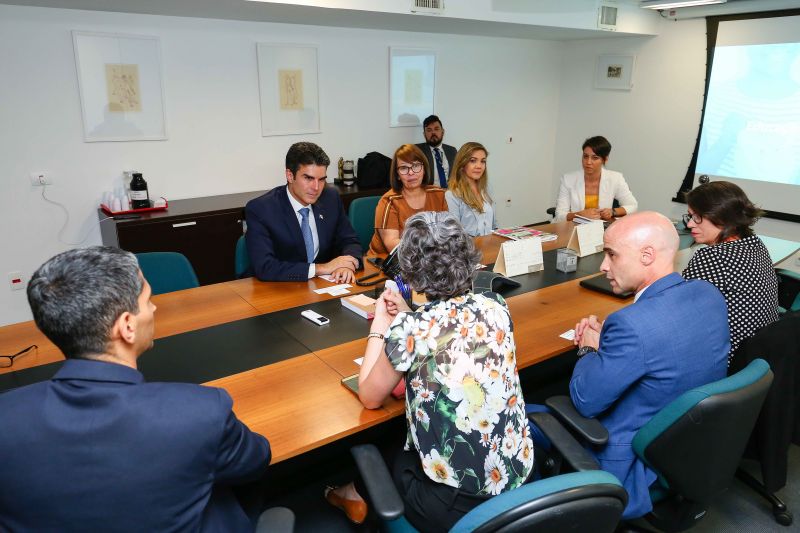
[{"x1": 633, "y1": 359, "x2": 773, "y2": 505}]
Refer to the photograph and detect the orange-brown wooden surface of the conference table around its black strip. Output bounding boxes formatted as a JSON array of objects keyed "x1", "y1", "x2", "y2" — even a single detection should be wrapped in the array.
[{"x1": 0, "y1": 222, "x2": 632, "y2": 463}]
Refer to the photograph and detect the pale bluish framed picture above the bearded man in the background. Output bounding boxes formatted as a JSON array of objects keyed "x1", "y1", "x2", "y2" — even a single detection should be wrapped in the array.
[{"x1": 389, "y1": 47, "x2": 436, "y2": 128}]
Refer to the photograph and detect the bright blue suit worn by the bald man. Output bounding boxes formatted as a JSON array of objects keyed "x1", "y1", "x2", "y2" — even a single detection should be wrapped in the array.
[{"x1": 569, "y1": 273, "x2": 730, "y2": 518}]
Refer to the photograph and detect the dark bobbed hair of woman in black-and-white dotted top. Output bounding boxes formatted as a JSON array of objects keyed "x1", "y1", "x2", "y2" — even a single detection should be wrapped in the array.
[{"x1": 686, "y1": 181, "x2": 764, "y2": 243}]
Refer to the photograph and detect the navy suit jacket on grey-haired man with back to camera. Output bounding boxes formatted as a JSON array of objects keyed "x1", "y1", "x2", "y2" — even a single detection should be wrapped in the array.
[{"x1": 0, "y1": 359, "x2": 270, "y2": 531}]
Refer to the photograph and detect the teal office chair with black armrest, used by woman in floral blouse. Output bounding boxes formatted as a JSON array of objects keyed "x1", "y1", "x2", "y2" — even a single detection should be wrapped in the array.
[{"x1": 351, "y1": 444, "x2": 628, "y2": 533}]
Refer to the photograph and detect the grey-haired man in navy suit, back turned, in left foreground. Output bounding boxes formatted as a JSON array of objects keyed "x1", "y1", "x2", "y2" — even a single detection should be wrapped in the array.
[{"x1": 0, "y1": 247, "x2": 270, "y2": 531}]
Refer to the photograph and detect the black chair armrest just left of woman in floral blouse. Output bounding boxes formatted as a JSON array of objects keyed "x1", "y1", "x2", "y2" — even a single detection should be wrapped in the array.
[{"x1": 350, "y1": 444, "x2": 404, "y2": 520}]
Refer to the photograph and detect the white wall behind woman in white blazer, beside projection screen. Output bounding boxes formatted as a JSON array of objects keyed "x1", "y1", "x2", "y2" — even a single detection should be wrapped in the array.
[{"x1": 551, "y1": 19, "x2": 800, "y2": 240}]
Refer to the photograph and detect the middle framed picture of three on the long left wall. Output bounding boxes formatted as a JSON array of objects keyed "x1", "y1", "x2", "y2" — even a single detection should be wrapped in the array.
[{"x1": 256, "y1": 43, "x2": 320, "y2": 137}]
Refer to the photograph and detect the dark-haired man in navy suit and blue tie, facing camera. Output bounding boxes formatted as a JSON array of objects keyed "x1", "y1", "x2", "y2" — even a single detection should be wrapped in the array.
[{"x1": 245, "y1": 142, "x2": 362, "y2": 283}]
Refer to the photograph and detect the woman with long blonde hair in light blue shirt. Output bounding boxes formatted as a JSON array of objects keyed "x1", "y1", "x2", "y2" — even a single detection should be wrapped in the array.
[{"x1": 445, "y1": 142, "x2": 497, "y2": 237}]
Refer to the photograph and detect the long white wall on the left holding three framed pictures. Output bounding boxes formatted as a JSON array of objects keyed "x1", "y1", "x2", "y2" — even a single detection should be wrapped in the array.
[{"x1": 0, "y1": 5, "x2": 562, "y2": 324}]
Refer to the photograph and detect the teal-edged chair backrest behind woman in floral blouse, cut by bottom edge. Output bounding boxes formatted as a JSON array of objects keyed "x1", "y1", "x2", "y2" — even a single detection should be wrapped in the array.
[{"x1": 451, "y1": 470, "x2": 628, "y2": 533}]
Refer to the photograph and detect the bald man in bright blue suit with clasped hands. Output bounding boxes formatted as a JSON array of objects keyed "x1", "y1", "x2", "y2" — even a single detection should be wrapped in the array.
[{"x1": 569, "y1": 212, "x2": 730, "y2": 518}]
